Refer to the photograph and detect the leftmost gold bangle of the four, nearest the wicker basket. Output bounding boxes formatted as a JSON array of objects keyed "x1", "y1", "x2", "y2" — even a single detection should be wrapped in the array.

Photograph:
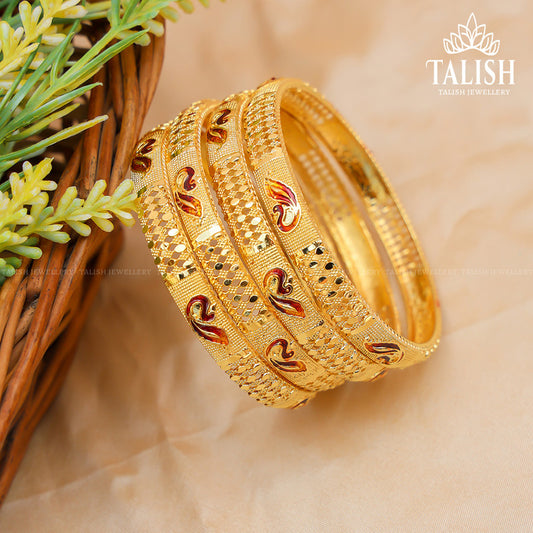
[{"x1": 131, "y1": 128, "x2": 314, "y2": 407}]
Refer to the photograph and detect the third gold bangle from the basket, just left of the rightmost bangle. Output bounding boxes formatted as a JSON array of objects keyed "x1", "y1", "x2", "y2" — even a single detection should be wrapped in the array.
[{"x1": 203, "y1": 93, "x2": 388, "y2": 381}]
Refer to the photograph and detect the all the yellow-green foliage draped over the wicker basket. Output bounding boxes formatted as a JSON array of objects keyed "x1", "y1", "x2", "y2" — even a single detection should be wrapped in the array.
[{"x1": 0, "y1": 0, "x2": 220, "y2": 283}]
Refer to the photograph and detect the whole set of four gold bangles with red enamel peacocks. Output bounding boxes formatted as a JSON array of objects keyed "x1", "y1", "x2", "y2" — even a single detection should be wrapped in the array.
[{"x1": 131, "y1": 79, "x2": 440, "y2": 407}]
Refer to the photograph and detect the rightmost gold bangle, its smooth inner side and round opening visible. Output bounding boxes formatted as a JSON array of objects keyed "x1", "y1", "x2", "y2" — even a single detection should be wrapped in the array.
[{"x1": 243, "y1": 79, "x2": 440, "y2": 368}]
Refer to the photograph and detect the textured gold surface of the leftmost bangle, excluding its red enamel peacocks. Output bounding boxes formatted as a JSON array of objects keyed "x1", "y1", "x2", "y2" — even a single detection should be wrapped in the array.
[{"x1": 132, "y1": 128, "x2": 313, "y2": 407}]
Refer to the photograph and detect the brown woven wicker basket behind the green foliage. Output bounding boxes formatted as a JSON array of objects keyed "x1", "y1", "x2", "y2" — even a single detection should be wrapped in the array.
[{"x1": 0, "y1": 25, "x2": 164, "y2": 502}]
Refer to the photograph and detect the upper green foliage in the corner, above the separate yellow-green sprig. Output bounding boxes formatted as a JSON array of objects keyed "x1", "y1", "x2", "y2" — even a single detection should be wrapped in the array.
[{"x1": 0, "y1": 0, "x2": 220, "y2": 174}]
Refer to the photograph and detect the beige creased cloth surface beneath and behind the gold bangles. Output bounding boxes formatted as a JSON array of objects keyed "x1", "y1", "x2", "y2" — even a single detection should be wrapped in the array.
[{"x1": 0, "y1": 0, "x2": 533, "y2": 532}]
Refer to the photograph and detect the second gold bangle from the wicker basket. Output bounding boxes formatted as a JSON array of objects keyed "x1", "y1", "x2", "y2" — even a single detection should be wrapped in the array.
[{"x1": 163, "y1": 103, "x2": 346, "y2": 391}]
